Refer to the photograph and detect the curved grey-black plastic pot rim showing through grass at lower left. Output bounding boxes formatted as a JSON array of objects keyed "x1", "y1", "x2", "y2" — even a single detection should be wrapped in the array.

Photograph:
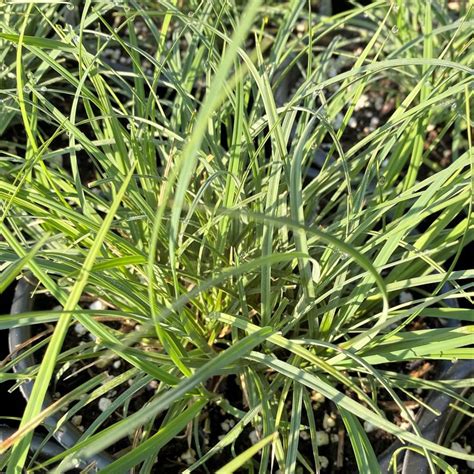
[{"x1": 9, "y1": 279, "x2": 114, "y2": 469}]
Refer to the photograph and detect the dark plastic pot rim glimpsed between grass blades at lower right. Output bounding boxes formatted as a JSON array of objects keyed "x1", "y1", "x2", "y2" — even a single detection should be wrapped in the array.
[{"x1": 379, "y1": 284, "x2": 474, "y2": 474}]
